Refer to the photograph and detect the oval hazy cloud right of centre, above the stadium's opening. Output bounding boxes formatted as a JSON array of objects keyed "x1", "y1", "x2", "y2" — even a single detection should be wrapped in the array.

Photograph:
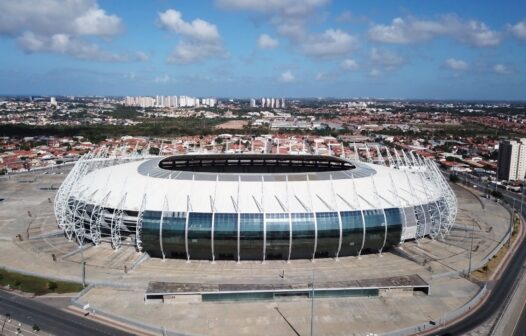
[{"x1": 302, "y1": 29, "x2": 358, "y2": 58}]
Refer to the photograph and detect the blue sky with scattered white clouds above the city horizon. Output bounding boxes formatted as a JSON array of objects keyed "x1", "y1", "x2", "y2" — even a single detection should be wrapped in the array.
[{"x1": 0, "y1": 0, "x2": 526, "y2": 100}]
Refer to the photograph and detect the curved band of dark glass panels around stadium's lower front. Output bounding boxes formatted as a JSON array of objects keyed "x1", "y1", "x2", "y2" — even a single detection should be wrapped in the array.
[{"x1": 137, "y1": 207, "x2": 408, "y2": 260}]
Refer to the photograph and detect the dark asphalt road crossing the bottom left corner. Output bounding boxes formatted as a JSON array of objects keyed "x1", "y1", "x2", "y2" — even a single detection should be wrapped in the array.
[{"x1": 0, "y1": 290, "x2": 132, "y2": 336}]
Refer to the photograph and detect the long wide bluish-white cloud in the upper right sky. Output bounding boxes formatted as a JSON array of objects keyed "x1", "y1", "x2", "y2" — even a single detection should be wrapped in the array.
[{"x1": 368, "y1": 15, "x2": 502, "y2": 47}]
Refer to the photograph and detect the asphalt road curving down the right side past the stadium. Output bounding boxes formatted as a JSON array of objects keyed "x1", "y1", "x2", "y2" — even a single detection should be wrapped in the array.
[{"x1": 436, "y1": 176, "x2": 526, "y2": 336}]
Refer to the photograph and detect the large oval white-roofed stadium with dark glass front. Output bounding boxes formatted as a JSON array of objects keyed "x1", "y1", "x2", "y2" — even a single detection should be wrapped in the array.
[{"x1": 54, "y1": 148, "x2": 457, "y2": 261}]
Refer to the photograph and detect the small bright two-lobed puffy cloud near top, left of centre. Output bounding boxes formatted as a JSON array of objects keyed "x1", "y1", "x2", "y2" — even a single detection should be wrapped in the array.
[{"x1": 159, "y1": 9, "x2": 221, "y2": 42}]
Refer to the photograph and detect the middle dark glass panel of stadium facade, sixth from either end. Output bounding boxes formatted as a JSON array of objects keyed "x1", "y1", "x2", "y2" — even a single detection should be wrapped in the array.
[{"x1": 265, "y1": 213, "x2": 290, "y2": 260}]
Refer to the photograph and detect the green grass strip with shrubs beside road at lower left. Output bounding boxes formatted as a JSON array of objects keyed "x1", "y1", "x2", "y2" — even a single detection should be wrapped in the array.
[{"x1": 0, "y1": 268, "x2": 82, "y2": 295}]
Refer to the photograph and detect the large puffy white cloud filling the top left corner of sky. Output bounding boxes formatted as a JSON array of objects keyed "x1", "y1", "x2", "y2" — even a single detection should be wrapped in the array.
[{"x1": 0, "y1": 0, "x2": 131, "y2": 62}]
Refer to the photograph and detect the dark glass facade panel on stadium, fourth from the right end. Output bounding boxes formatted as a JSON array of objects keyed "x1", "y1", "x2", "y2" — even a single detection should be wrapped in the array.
[{"x1": 316, "y1": 212, "x2": 340, "y2": 258}]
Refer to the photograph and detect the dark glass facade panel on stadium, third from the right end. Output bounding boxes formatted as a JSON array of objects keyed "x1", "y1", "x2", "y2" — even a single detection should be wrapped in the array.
[{"x1": 340, "y1": 211, "x2": 363, "y2": 256}]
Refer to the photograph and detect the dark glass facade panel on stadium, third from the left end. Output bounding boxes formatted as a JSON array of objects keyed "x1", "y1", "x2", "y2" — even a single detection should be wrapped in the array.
[{"x1": 188, "y1": 212, "x2": 212, "y2": 259}]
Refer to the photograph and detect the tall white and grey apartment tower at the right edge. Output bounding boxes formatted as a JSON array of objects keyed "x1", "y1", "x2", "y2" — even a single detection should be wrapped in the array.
[{"x1": 497, "y1": 138, "x2": 526, "y2": 181}]
